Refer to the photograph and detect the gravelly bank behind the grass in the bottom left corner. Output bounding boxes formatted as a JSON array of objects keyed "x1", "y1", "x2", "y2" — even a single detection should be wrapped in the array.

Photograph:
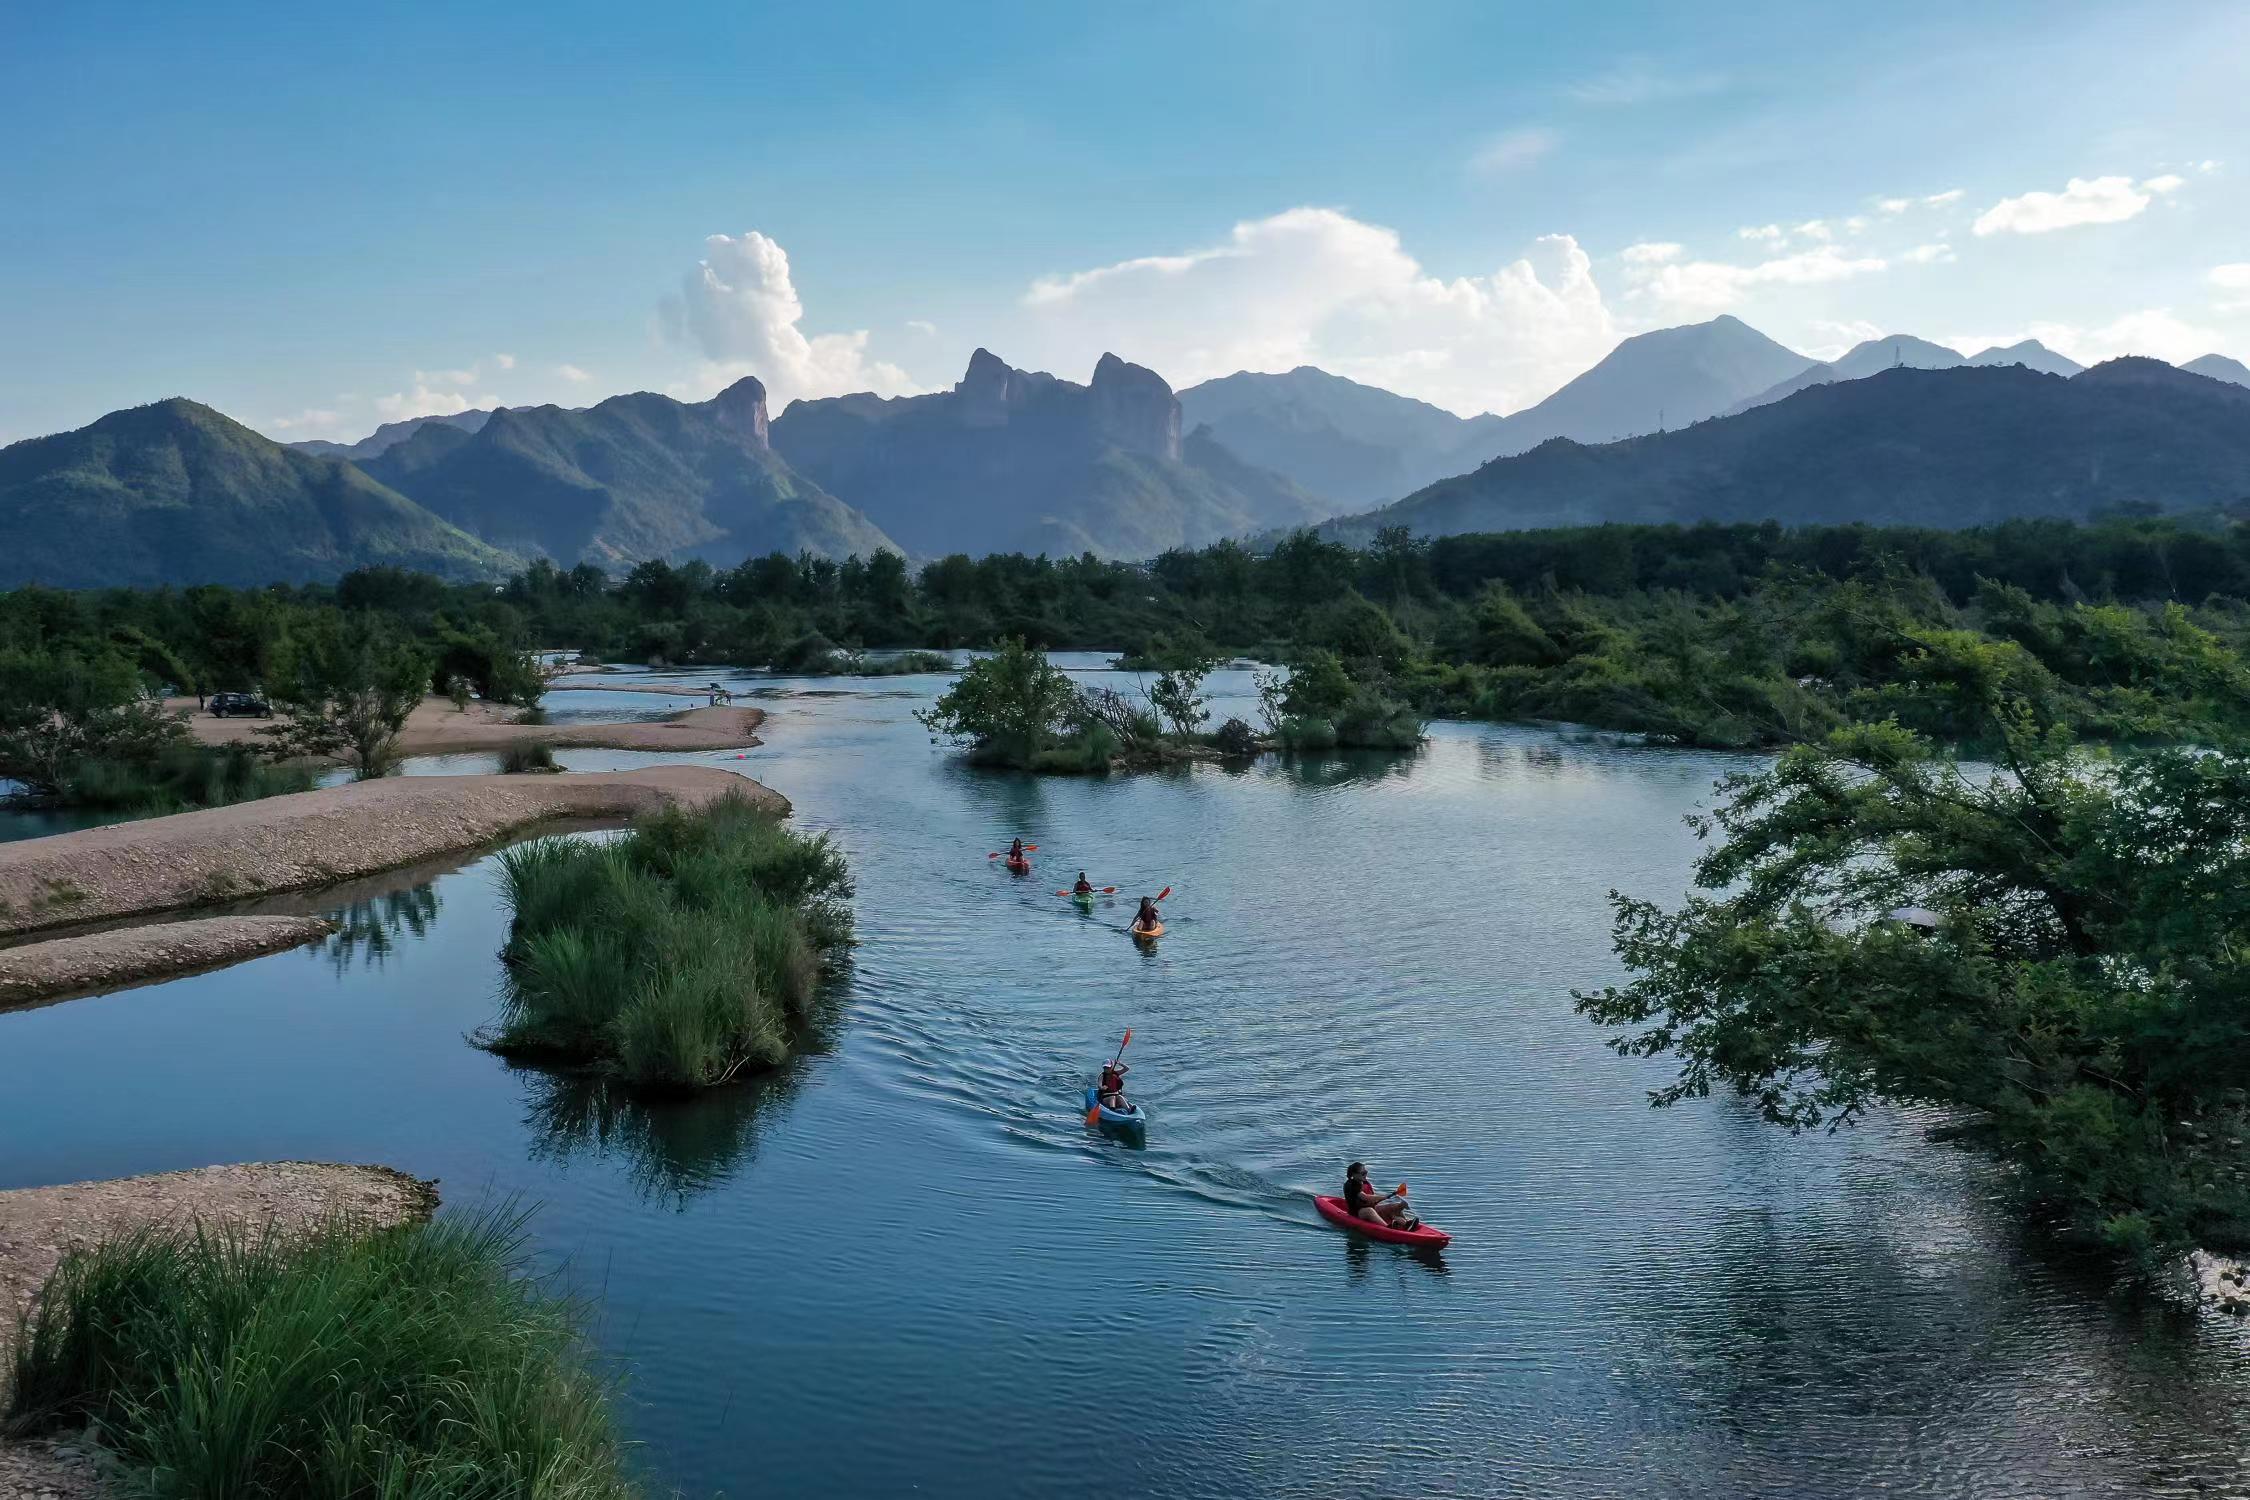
[{"x1": 0, "y1": 1160, "x2": 437, "y2": 1500}]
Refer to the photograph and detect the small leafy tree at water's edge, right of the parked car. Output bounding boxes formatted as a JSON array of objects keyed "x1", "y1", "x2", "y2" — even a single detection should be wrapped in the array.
[{"x1": 261, "y1": 616, "x2": 432, "y2": 780}]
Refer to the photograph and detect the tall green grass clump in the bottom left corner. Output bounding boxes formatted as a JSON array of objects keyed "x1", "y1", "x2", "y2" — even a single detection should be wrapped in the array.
[{"x1": 0, "y1": 1214, "x2": 637, "y2": 1500}]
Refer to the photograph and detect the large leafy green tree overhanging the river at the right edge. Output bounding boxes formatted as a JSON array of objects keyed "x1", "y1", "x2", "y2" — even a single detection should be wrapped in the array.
[{"x1": 1580, "y1": 629, "x2": 2250, "y2": 1275}]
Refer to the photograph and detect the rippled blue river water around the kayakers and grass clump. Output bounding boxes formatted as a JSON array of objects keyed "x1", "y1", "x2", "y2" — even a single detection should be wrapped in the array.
[{"x1": 0, "y1": 661, "x2": 2250, "y2": 1496}]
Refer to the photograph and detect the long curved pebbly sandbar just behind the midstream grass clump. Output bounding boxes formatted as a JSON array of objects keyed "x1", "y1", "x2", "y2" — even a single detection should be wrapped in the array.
[{"x1": 0, "y1": 765, "x2": 790, "y2": 936}]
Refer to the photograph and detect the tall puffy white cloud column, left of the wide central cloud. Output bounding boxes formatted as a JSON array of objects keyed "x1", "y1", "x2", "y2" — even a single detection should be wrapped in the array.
[{"x1": 659, "y1": 229, "x2": 916, "y2": 412}]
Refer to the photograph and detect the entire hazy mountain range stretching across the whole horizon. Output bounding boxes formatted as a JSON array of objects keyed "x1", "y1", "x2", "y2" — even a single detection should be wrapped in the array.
[{"x1": 13, "y1": 317, "x2": 2250, "y2": 587}]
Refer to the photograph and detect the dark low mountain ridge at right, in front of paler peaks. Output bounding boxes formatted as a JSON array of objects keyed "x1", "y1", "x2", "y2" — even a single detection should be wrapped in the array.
[{"x1": 1328, "y1": 358, "x2": 2250, "y2": 548}]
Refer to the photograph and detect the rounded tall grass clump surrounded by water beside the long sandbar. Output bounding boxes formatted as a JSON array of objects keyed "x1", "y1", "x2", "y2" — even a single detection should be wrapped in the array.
[{"x1": 482, "y1": 796, "x2": 851, "y2": 1093}]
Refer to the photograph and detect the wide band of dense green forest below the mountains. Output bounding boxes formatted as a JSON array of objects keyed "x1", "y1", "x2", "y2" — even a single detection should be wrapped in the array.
[{"x1": 0, "y1": 515, "x2": 2250, "y2": 805}]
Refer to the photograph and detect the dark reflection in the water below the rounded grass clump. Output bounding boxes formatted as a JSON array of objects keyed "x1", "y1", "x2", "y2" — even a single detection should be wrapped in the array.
[{"x1": 511, "y1": 985, "x2": 835, "y2": 1208}]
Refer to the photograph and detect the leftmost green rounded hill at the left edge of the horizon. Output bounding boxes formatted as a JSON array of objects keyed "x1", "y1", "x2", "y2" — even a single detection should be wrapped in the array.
[{"x1": 0, "y1": 396, "x2": 518, "y2": 589}]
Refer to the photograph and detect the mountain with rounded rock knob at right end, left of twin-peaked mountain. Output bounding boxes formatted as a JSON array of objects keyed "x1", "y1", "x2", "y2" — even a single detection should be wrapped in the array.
[{"x1": 362, "y1": 378, "x2": 898, "y2": 569}]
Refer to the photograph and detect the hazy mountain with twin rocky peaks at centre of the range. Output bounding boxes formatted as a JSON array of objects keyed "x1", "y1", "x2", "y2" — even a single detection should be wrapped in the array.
[{"x1": 774, "y1": 349, "x2": 1343, "y2": 558}]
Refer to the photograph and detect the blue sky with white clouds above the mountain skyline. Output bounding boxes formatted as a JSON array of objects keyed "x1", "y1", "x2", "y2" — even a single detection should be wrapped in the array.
[{"x1": 0, "y1": 0, "x2": 2250, "y2": 441}]
